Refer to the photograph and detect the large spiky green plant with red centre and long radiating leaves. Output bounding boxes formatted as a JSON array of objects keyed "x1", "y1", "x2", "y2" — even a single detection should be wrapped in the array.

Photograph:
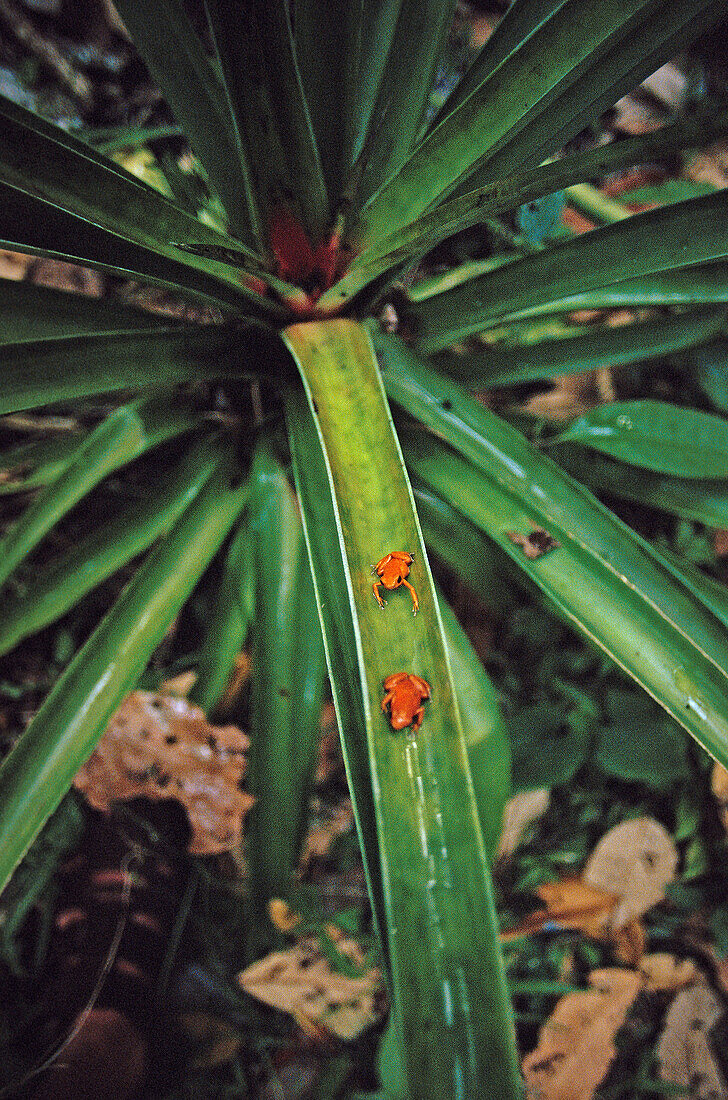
[{"x1": 0, "y1": 0, "x2": 728, "y2": 1100}]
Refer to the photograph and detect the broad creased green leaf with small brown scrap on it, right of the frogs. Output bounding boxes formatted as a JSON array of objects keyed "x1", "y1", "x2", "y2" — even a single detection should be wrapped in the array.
[{"x1": 374, "y1": 332, "x2": 728, "y2": 761}]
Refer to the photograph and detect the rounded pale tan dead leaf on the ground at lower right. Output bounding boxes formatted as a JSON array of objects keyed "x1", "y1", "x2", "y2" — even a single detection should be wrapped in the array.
[{"x1": 582, "y1": 817, "x2": 677, "y2": 928}]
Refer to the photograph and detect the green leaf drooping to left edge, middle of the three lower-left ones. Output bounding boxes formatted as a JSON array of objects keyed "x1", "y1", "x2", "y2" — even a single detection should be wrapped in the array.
[{"x1": 0, "y1": 426, "x2": 224, "y2": 653}]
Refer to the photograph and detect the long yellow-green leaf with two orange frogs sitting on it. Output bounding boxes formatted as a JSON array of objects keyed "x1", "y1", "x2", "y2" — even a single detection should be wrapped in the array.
[{"x1": 285, "y1": 320, "x2": 520, "y2": 1100}]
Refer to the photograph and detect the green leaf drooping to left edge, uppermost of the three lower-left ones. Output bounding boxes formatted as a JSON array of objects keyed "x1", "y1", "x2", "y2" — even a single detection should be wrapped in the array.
[{"x1": 0, "y1": 393, "x2": 199, "y2": 585}]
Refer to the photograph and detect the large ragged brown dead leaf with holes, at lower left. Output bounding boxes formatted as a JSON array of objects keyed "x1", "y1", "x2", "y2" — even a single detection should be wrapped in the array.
[{"x1": 74, "y1": 691, "x2": 254, "y2": 856}]
